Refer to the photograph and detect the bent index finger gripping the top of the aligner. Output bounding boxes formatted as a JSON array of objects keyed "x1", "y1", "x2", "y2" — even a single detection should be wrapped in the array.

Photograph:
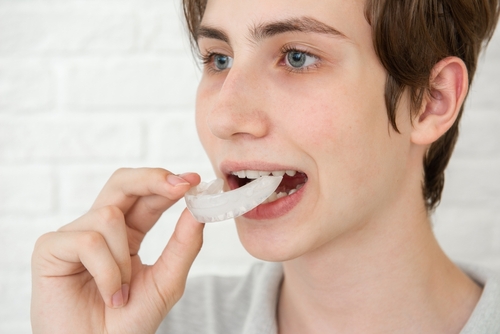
[{"x1": 92, "y1": 168, "x2": 200, "y2": 215}]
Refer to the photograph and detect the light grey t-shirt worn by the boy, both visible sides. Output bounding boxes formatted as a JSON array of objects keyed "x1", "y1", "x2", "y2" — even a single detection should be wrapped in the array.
[{"x1": 157, "y1": 262, "x2": 500, "y2": 334}]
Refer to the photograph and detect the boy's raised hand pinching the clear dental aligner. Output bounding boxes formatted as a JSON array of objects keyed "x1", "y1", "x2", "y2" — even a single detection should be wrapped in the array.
[{"x1": 31, "y1": 168, "x2": 204, "y2": 334}]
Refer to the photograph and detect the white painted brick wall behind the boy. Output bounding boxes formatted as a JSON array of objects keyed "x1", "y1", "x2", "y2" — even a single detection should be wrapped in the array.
[{"x1": 0, "y1": 0, "x2": 500, "y2": 334}]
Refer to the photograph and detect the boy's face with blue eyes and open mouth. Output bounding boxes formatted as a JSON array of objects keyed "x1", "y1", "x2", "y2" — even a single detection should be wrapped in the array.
[{"x1": 196, "y1": 0, "x2": 411, "y2": 260}]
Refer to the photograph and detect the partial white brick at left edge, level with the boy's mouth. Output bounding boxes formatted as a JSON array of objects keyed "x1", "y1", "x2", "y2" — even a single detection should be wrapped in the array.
[{"x1": 0, "y1": 165, "x2": 55, "y2": 213}]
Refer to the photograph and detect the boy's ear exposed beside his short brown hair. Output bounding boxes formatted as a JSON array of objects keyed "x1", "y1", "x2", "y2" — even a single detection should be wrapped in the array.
[{"x1": 411, "y1": 57, "x2": 469, "y2": 145}]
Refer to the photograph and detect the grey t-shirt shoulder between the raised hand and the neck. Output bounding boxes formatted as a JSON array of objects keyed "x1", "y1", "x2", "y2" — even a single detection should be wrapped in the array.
[{"x1": 158, "y1": 263, "x2": 283, "y2": 334}]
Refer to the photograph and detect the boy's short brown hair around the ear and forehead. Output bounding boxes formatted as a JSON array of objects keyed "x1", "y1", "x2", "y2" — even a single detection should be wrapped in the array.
[{"x1": 183, "y1": 0, "x2": 500, "y2": 211}]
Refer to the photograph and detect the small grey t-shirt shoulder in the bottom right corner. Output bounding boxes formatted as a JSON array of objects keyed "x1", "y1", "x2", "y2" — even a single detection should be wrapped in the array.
[{"x1": 459, "y1": 264, "x2": 500, "y2": 334}]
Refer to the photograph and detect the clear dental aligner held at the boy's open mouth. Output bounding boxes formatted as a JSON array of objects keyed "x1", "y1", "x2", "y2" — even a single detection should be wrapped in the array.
[{"x1": 184, "y1": 176, "x2": 283, "y2": 223}]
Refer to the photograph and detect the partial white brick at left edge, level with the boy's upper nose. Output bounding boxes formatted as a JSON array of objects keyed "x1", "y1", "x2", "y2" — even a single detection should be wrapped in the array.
[{"x1": 0, "y1": 59, "x2": 55, "y2": 112}]
